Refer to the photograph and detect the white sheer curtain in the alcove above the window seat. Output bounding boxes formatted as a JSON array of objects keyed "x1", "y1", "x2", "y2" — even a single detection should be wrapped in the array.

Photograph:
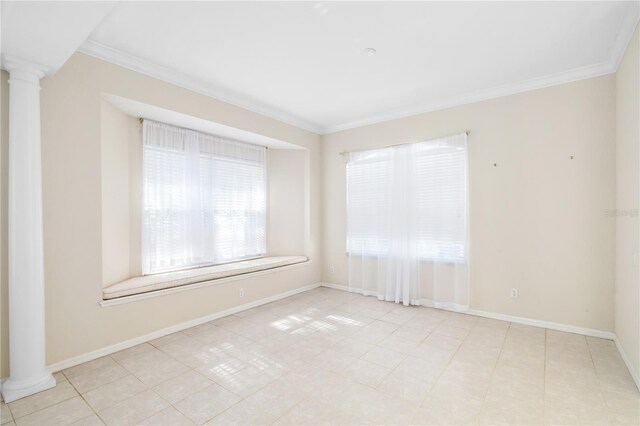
[{"x1": 142, "y1": 120, "x2": 266, "y2": 274}]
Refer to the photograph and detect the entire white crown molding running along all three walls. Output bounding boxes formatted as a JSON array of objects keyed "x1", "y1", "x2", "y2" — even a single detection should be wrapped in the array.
[{"x1": 78, "y1": 11, "x2": 639, "y2": 135}]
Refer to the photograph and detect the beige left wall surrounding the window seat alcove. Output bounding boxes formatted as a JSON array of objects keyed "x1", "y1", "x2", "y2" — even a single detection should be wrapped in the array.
[{"x1": 1, "y1": 54, "x2": 321, "y2": 377}]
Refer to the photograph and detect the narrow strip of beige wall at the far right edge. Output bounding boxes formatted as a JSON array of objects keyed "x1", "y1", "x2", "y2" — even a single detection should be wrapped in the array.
[{"x1": 615, "y1": 28, "x2": 640, "y2": 380}]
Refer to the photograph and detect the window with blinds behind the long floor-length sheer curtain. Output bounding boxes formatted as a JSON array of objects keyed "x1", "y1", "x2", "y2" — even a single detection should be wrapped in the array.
[{"x1": 347, "y1": 135, "x2": 467, "y2": 262}]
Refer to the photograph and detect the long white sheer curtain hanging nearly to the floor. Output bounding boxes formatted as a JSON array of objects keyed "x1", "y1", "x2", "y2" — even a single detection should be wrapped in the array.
[{"x1": 347, "y1": 133, "x2": 469, "y2": 311}]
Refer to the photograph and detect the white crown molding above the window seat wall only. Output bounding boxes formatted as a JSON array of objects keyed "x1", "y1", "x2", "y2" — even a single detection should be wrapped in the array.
[{"x1": 78, "y1": 39, "x2": 322, "y2": 134}]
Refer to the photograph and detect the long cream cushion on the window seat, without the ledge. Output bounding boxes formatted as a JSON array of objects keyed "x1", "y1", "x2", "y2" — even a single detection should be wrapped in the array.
[{"x1": 102, "y1": 256, "x2": 309, "y2": 300}]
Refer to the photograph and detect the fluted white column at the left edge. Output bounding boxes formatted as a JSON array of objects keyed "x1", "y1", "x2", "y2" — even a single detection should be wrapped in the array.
[{"x1": 2, "y1": 59, "x2": 56, "y2": 402}]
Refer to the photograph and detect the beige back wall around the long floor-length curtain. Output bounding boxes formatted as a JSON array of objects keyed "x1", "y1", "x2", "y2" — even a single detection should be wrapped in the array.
[{"x1": 322, "y1": 75, "x2": 615, "y2": 331}]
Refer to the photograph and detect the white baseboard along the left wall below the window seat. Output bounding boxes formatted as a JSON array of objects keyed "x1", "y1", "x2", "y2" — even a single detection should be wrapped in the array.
[{"x1": 48, "y1": 283, "x2": 320, "y2": 373}]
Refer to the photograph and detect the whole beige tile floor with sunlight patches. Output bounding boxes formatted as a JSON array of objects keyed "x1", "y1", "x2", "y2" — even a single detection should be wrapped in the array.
[{"x1": 0, "y1": 288, "x2": 640, "y2": 426}]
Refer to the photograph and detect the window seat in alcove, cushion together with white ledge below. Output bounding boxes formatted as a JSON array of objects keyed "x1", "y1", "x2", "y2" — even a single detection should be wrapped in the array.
[{"x1": 100, "y1": 256, "x2": 309, "y2": 306}]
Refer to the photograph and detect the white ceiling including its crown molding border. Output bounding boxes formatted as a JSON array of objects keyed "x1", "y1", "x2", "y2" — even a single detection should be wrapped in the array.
[{"x1": 3, "y1": 1, "x2": 638, "y2": 133}]
